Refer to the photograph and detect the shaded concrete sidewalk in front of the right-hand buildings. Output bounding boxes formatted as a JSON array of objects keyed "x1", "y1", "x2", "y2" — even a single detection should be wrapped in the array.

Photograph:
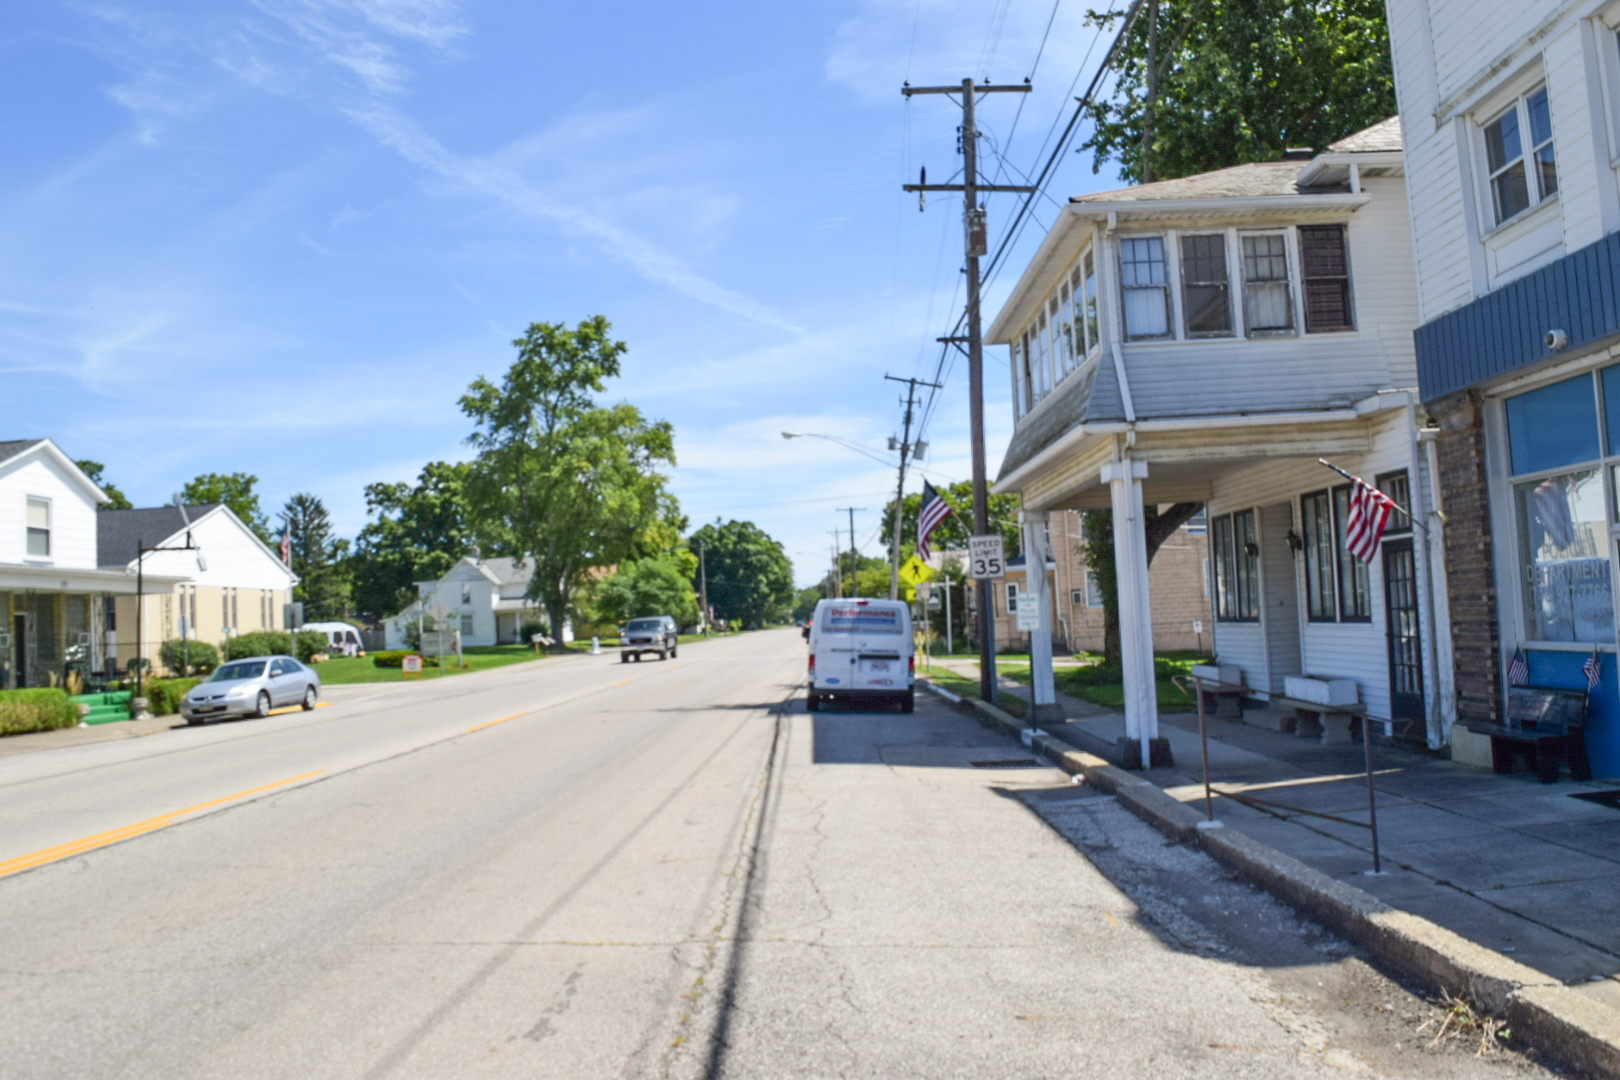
[{"x1": 926, "y1": 661, "x2": 1620, "y2": 1075}]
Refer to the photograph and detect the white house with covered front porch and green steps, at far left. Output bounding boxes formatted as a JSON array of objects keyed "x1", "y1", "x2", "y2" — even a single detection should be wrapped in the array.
[{"x1": 0, "y1": 439, "x2": 178, "y2": 690}]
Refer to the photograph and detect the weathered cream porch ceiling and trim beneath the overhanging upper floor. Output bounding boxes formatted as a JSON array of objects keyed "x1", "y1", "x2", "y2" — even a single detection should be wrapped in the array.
[{"x1": 996, "y1": 418, "x2": 1372, "y2": 510}]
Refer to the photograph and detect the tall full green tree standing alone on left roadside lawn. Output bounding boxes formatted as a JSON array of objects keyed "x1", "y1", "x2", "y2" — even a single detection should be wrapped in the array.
[{"x1": 462, "y1": 316, "x2": 676, "y2": 641}]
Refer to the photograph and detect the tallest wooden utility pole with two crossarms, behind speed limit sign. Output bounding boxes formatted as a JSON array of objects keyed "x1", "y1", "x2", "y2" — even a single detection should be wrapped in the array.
[{"x1": 901, "y1": 79, "x2": 1035, "y2": 701}]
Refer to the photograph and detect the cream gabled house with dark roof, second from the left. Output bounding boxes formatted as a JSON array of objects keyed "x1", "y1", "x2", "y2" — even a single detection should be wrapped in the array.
[{"x1": 96, "y1": 504, "x2": 298, "y2": 667}]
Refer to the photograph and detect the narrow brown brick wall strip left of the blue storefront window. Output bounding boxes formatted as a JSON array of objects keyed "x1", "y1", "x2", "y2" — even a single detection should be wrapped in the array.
[{"x1": 1427, "y1": 390, "x2": 1502, "y2": 722}]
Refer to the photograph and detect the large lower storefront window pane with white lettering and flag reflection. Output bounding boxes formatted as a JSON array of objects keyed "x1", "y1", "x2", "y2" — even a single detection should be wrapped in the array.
[{"x1": 1513, "y1": 466, "x2": 1615, "y2": 641}]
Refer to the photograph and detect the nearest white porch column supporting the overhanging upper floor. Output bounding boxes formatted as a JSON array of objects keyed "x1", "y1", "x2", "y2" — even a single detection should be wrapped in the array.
[{"x1": 1102, "y1": 458, "x2": 1170, "y2": 766}]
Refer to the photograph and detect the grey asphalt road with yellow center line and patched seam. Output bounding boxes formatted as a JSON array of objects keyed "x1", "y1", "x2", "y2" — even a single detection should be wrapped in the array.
[{"x1": 0, "y1": 631, "x2": 1568, "y2": 1080}]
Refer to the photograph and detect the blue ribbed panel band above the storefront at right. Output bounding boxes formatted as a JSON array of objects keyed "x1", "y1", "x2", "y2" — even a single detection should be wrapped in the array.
[{"x1": 1413, "y1": 233, "x2": 1620, "y2": 402}]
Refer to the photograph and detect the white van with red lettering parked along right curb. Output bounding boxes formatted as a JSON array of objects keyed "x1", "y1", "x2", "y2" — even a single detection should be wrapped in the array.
[{"x1": 805, "y1": 599, "x2": 917, "y2": 712}]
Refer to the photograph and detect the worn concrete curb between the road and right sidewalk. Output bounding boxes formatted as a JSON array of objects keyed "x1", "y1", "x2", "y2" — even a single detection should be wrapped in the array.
[{"x1": 930, "y1": 687, "x2": 1620, "y2": 1077}]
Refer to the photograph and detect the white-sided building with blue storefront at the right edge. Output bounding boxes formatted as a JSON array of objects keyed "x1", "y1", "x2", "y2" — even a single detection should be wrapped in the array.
[{"x1": 1388, "y1": 0, "x2": 1620, "y2": 776}]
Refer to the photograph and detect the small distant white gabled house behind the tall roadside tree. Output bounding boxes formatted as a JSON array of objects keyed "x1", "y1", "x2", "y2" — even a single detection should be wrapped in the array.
[{"x1": 384, "y1": 555, "x2": 560, "y2": 649}]
